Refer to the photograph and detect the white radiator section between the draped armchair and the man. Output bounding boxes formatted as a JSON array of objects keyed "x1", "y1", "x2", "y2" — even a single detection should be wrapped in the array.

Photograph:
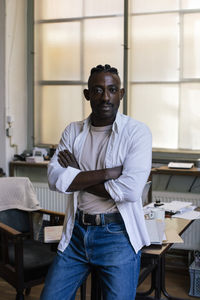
[{"x1": 33, "y1": 182, "x2": 70, "y2": 212}]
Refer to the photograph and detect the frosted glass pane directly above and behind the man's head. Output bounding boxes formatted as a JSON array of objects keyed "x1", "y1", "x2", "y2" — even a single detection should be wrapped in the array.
[{"x1": 83, "y1": 17, "x2": 123, "y2": 81}]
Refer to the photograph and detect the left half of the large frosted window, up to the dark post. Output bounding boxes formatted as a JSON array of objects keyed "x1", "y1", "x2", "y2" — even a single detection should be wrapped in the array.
[{"x1": 34, "y1": 0, "x2": 124, "y2": 144}]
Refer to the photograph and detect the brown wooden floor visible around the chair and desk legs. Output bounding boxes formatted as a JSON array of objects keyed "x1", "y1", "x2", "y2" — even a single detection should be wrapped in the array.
[{"x1": 0, "y1": 271, "x2": 199, "y2": 300}]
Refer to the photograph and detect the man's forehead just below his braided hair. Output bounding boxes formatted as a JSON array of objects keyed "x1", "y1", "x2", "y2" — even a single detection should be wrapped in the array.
[{"x1": 88, "y1": 72, "x2": 120, "y2": 88}]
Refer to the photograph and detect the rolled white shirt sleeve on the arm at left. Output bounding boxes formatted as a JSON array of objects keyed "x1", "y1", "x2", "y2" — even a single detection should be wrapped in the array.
[{"x1": 47, "y1": 125, "x2": 81, "y2": 194}]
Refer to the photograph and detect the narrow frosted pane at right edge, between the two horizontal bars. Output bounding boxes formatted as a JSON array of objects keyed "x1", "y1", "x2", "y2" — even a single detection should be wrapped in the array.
[{"x1": 183, "y1": 13, "x2": 200, "y2": 78}]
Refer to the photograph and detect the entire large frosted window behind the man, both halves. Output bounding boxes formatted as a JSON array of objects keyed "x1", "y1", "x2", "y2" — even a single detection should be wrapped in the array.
[{"x1": 34, "y1": 0, "x2": 200, "y2": 151}]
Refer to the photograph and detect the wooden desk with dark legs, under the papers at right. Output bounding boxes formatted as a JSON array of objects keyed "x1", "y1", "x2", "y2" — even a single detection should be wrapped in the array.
[{"x1": 135, "y1": 218, "x2": 193, "y2": 300}]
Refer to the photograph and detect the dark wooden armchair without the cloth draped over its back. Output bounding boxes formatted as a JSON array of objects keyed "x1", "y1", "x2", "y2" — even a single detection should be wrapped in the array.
[{"x1": 0, "y1": 209, "x2": 64, "y2": 300}]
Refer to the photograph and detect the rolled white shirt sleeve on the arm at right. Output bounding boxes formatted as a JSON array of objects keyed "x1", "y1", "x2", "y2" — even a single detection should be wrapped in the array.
[{"x1": 104, "y1": 124, "x2": 152, "y2": 202}]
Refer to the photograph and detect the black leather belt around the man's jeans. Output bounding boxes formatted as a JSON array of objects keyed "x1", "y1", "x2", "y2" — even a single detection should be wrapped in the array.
[{"x1": 76, "y1": 210, "x2": 123, "y2": 226}]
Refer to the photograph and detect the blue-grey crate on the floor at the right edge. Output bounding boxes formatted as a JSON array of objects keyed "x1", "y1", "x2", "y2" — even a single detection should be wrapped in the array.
[{"x1": 189, "y1": 251, "x2": 200, "y2": 297}]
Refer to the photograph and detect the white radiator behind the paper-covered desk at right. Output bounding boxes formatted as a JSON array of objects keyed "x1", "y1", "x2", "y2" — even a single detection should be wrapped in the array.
[{"x1": 152, "y1": 191, "x2": 200, "y2": 250}]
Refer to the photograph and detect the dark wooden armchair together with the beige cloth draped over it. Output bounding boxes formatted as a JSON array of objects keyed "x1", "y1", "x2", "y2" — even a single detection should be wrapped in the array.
[{"x1": 0, "y1": 177, "x2": 86, "y2": 300}]
